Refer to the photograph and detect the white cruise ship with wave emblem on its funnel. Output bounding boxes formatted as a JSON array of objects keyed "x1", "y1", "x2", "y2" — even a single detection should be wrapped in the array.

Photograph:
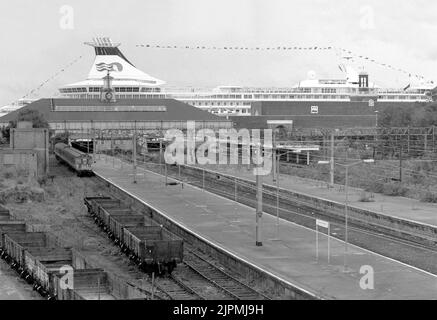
[{"x1": 2, "y1": 38, "x2": 436, "y2": 116}]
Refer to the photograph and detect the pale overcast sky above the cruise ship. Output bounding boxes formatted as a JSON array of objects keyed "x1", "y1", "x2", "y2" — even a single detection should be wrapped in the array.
[{"x1": 0, "y1": 0, "x2": 437, "y2": 105}]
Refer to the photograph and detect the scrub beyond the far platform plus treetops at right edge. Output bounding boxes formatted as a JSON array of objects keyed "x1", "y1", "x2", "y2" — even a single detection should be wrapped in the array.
[{"x1": 281, "y1": 102, "x2": 437, "y2": 203}]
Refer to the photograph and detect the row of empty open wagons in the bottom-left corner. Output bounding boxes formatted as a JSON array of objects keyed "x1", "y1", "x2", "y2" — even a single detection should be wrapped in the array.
[{"x1": 0, "y1": 220, "x2": 116, "y2": 300}]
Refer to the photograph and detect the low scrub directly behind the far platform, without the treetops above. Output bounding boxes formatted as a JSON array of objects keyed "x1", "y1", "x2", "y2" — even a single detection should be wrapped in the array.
[{"x1": 281, "y1": 140, "x2": 437, "y2": 202}]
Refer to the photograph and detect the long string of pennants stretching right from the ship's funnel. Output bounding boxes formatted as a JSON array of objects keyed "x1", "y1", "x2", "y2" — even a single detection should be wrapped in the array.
[{"x1": 136, "y1": 44, "x2": 425, "y2": 80}]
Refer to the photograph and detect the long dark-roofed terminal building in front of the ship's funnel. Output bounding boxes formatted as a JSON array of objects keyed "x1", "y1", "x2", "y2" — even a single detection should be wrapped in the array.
[{"x1": 0, "y1": 99, "x2": 232, "y2": 132}]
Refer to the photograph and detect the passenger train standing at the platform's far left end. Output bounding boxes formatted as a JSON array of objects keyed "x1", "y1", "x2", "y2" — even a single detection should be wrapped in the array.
[{"x1": 55, "y1": 143, "x2": 93, "y2": 176}]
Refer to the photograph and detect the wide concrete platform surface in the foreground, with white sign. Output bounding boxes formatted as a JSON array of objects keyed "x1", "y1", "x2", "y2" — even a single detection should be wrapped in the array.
[{"x1": 94, "y1": 158, "x2": 437, "y2": 299}]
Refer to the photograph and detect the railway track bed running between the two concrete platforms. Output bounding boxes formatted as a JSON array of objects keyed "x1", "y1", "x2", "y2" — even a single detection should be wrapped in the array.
[{"x1": 130, "y1": 158, "x2": 437, "y2": 274}]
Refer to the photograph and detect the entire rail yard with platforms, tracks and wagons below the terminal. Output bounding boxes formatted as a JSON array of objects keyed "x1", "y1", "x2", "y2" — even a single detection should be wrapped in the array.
[{"x1": 0, "y1": 125, "x2": 437, "y2": 301}]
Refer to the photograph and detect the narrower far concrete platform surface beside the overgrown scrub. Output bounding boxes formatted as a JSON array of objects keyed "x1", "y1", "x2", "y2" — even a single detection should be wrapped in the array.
[{"x1": 192, "y1": 165, "x2": 437, "y2": 226}]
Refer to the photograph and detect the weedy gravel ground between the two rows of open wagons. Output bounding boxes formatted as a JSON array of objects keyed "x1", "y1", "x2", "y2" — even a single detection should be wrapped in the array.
[{"x1": 2, "y1": 159, "x2": 255, "y2": 299}]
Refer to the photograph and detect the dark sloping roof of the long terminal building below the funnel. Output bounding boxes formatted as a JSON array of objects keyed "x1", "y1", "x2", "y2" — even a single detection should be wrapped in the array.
[{"x1": 0, "y1": 99, "x2": 227, "y2": 123}]
